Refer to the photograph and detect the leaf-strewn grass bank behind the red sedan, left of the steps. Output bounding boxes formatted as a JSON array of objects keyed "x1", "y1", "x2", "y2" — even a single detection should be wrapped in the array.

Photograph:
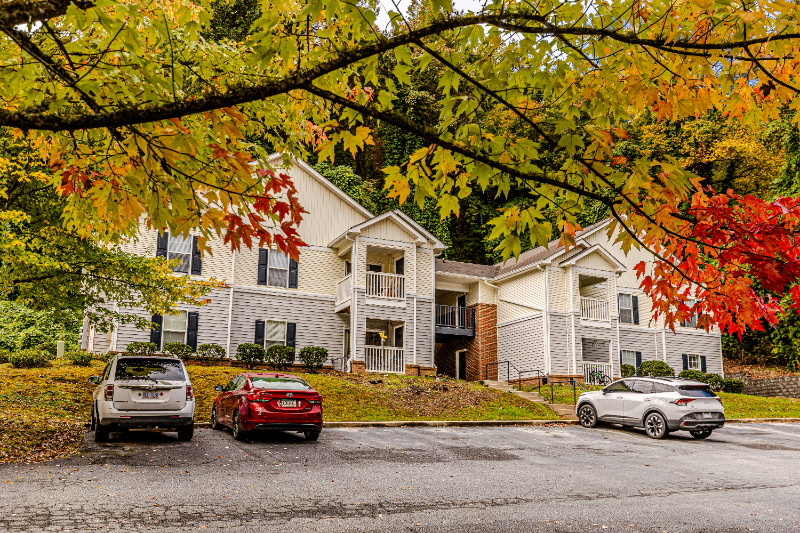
[{"x1": 0, "y1": 361, "x2": 559, "y2": 462}]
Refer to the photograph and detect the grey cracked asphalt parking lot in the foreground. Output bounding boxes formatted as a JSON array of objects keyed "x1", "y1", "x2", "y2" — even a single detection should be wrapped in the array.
[{"x1": 0, "y1": 424, "x2": 800, "y2": 533}]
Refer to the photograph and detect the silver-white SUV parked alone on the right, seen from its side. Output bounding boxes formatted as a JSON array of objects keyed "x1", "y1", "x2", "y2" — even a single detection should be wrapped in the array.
[{"x1": 575, "y1": 376, "x2": 725, "y2": 439}]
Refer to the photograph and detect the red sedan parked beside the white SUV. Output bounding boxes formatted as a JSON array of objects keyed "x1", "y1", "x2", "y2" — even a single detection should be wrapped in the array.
[{"x1": 211, "y1": 372, "x2": 322, "y2": 440}]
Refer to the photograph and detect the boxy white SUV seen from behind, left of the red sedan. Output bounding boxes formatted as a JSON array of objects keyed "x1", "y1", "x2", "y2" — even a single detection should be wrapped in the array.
[{"x1": 89, "y1": 355, "x2": 194, "y2": 442}]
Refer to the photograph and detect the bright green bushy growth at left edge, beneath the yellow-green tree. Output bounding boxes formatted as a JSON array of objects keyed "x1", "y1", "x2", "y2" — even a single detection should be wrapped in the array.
[{"x1": 0, "y1": 301, "x2": 83, "y2": 351}]
